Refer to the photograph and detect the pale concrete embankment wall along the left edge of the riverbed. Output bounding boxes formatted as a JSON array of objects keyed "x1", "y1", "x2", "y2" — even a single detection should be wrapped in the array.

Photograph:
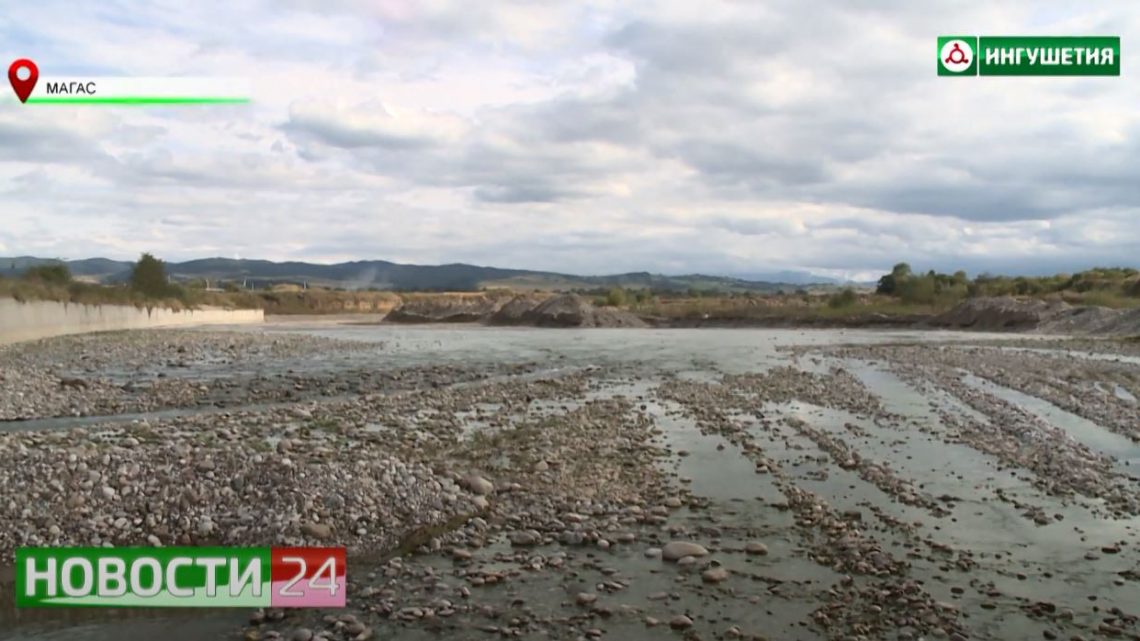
[{"x1": 0, "y1": 299, "x2": 264, "y2": 344}]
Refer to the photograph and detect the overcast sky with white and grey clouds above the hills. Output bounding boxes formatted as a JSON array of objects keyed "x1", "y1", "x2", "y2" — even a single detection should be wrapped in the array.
[{"x1": 0, "y1": 0, "x2": 1140, "y2": 276}]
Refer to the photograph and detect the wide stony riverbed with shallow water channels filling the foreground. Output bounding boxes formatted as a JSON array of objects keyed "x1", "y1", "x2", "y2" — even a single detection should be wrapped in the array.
[{"x1": 0, "y1": 326, "x2": 1140, "y2": 641}]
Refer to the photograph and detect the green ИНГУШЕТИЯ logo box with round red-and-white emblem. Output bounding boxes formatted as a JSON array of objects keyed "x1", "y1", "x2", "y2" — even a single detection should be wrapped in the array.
[{"x1": 938, "y1": 35, "x2": 1121, "y2": 76}]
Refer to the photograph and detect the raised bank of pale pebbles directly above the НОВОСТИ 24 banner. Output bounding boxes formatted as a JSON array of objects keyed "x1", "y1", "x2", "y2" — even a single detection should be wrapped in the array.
[{"x1": 0, "y1": 424, "x2": 477, "y2": 560}]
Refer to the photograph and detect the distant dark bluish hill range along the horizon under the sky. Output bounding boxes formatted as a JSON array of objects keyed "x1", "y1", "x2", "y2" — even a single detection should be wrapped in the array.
[{"x1": 0, "y1": 257, "x2": 842, "y2": 292}]
